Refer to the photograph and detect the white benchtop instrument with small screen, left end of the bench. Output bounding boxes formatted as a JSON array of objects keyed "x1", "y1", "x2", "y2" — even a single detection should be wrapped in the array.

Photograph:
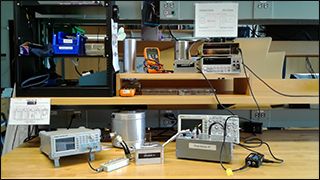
[{"x1": 39, "y1": 127, "x2": 101, "y2": 167}]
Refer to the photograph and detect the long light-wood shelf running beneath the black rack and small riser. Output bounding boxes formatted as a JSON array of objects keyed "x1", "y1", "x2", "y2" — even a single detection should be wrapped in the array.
[{"x1": 43, "y1": 95, "x2": 319, "y2": 105}]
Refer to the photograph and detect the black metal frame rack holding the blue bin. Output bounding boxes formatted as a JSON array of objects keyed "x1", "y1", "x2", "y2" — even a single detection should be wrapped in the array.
[{"x1": 14, "y1": 1, "x2": 118, "y2": 97}]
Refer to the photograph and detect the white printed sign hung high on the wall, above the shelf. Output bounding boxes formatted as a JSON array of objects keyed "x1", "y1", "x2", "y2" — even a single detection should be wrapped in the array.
[{"x1": 194, "y1": 2, "x2": 238, "y2": 37}]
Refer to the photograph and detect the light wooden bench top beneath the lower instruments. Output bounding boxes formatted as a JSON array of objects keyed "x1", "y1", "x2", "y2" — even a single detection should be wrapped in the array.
[{"x1": 1, "y1": 129, "x2": 319, "y2": 179}]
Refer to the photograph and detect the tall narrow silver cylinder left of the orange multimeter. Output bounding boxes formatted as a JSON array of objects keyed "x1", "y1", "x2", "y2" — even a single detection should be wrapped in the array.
[{"x1": 123, "y1": 39, "x2": 137, "y2": 73}]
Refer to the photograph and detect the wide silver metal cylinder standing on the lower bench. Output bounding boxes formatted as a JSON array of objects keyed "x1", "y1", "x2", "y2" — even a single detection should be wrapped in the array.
[{"x1": 112, "y1": 111, "x2": 146, "y2": 148}]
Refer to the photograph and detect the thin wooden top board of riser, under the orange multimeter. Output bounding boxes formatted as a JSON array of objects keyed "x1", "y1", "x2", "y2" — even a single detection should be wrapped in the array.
[{"x1": 118, "y1": 73, "x2": 246, "y2": 80}]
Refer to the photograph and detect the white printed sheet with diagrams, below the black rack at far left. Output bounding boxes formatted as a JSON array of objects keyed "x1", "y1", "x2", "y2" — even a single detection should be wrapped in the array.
[{"x1": 8, "y1": 98, "x2": 51, "y2": 125}]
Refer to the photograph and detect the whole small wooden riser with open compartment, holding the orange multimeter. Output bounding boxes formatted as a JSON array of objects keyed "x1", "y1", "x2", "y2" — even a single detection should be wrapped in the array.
[{"x1": 116, "y1": 73, "x2": 248, "y2": 96}]
